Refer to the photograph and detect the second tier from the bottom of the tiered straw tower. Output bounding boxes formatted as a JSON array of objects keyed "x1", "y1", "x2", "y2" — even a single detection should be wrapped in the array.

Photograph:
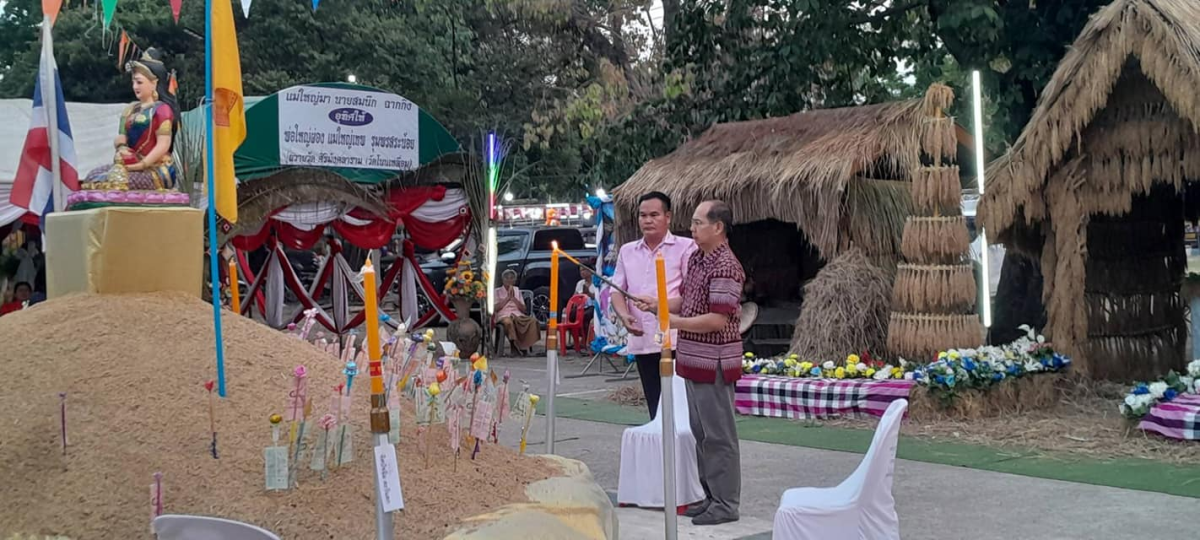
[{"x1": 892, "y1": 264, "x2": 976, "y2": 313}]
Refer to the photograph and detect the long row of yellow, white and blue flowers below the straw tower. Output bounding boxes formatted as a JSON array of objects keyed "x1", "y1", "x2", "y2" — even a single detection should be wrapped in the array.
[{"x1": 742, "y1": 326, "x2": 1070, "y2": 397}]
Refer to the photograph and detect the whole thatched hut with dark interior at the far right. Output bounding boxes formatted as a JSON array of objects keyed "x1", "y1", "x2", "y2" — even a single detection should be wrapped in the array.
[{"x1": 980, "y1": 0, "x2": 1200, "y2": 379}]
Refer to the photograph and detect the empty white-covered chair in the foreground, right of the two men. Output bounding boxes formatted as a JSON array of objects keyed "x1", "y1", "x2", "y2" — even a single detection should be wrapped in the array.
[{"x1": 774, "y1": 400, "x2": 908, "y2": 540}]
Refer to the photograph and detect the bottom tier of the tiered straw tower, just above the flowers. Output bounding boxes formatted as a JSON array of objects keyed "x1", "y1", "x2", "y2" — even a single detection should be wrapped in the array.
[{"x1": 888, "y1": 313, "x2": 983, "y2": 360}]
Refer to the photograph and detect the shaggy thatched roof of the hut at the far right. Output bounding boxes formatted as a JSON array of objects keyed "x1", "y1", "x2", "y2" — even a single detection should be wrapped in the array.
[{"x1": 979, "y1": 0, "x2": 1200, "y2": 244}]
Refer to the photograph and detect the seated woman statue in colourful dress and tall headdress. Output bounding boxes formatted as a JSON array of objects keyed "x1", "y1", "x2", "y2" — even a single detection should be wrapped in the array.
[{"x1": 80, "y1": 48, "x2": 180, "y2": 192}]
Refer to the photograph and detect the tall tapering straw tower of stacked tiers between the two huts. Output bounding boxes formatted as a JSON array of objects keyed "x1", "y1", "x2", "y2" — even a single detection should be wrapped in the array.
[{"x1": 892, "y1": 84, "x2": 983, "y2": 359}]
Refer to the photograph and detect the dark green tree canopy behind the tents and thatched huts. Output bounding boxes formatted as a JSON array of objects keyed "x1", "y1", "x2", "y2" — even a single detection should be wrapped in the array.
[{"x1": 0, "y1": 0, "x2": 1106, "y2": 199}]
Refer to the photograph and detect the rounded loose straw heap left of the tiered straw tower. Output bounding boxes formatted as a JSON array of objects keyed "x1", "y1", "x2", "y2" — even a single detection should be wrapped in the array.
[{"x1": 791, "y1": 248, "x2": 892, "y2": 361}]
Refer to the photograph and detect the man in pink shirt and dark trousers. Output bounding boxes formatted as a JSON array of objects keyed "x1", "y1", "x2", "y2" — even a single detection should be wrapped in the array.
[{"x1": 612, "y1": 191, "x2": 696, "y2": 419}]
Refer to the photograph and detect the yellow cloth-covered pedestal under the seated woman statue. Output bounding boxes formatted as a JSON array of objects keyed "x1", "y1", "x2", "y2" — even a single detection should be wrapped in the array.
[{"x1": 46, "y1": 206, "x2": 204, "y2": 298}]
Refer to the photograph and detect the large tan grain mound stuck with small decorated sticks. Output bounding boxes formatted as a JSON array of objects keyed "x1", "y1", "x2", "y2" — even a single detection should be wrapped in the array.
[{"x1": 0, "y1": 294, "x2": 559, "y2": 539}]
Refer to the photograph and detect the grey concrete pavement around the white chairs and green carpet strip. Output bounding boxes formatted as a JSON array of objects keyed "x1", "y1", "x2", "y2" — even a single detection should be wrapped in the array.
[{"x1": 493, "y1": 358, "x2": 1200, "y2": 540}]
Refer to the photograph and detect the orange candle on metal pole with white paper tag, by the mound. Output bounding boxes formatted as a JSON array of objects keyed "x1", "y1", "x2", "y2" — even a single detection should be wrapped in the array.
[{"x1": 362, "y1": 257, "x2": 403, "y2": 539}]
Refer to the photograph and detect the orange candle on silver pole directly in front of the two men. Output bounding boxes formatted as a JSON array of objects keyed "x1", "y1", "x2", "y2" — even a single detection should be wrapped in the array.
[{"x1": 654, "y1": 252, "x2": 676, "y2": 540}]
